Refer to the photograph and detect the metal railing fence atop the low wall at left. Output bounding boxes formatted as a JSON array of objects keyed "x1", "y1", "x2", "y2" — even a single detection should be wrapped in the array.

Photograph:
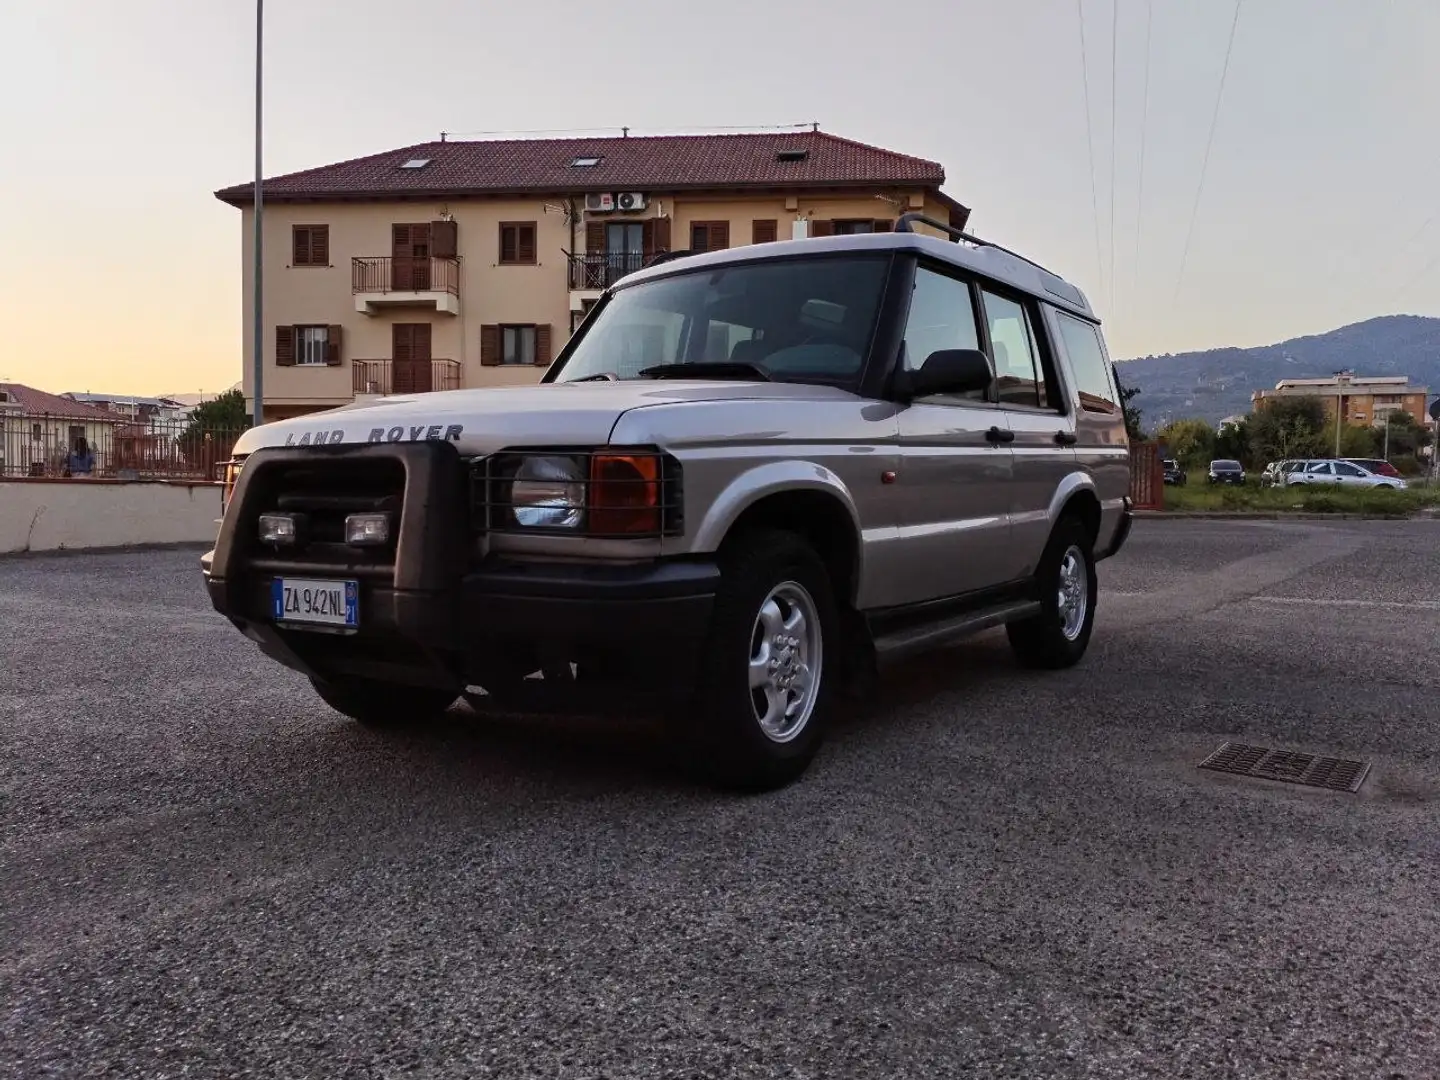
[{"x1": 0, "y1": 415, "x2": 242, "y2": 481}]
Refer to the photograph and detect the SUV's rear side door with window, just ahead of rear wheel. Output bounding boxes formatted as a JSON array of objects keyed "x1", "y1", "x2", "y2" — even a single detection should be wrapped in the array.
[{"x1": 981, "y1": 282, "x2": 1076, "y2": 577}]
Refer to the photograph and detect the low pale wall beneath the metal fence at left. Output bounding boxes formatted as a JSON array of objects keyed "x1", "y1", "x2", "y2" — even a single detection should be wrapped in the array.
[{"x1": 0, "y1": 480, "x2": 220, "y2": 554}]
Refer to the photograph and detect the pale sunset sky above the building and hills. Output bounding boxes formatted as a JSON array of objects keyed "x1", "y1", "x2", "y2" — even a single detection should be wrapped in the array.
[{"x1": 0, "y1": 0, "x2": 1440, "y2": 393}]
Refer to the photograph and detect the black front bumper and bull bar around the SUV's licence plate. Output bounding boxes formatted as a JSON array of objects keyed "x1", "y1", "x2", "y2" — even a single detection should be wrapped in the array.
[{"x1": 200, "y1": 444, "x2": 720, "y2": 685}]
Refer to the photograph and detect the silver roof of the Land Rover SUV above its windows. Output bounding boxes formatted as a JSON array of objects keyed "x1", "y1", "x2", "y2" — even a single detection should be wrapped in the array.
[{"x1": 615, "y1": 232, "x2": 1100, "y2": 323}]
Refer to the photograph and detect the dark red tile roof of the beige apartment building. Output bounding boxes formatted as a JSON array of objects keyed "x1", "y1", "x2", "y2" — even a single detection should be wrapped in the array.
[{"x1": 215, "y1": 131, "x2": 945, "y2": 206}]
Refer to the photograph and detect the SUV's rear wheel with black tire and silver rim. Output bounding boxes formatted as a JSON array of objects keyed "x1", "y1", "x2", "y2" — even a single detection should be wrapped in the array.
[{"x1": 1005, "y1": 517, "x2": 1097, "y2": 670}]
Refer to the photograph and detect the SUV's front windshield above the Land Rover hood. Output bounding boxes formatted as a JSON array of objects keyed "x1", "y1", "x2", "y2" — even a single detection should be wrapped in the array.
[{"x1": 556, "y1": 255, "x2": 888, "y2": 386}]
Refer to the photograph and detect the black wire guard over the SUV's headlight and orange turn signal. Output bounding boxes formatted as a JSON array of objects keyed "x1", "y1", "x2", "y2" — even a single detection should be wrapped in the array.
[{"x1": 469, "y1": 448, "x2": 685, "y2": 540}]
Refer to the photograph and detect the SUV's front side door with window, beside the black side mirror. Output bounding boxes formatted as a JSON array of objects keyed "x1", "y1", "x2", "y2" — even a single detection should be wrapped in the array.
[{"x1": 893, "y1": 266, "x2": 1014, "y2": 603}]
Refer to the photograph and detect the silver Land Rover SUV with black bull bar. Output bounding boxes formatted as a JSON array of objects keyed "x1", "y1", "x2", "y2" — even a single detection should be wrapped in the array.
[{"x1": 203, "y1": 215, "x2": 1130, "y2": 788}]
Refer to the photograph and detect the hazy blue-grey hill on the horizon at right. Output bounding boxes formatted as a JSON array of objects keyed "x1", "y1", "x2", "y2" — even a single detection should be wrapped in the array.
[{"x1": 1117, "y1": 315, "x2": 1440, "y2": 429}]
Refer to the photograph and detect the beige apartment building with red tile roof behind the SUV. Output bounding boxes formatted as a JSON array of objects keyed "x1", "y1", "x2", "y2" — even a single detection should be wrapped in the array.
[{"x1": 216, "y1": 130, "x2": 969, "y2": 419}]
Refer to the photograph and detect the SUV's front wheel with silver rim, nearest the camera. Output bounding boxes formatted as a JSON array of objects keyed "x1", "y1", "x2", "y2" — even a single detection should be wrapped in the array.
[{"x1": 683, "y1": 530, "x2": 842, "y2": 791}]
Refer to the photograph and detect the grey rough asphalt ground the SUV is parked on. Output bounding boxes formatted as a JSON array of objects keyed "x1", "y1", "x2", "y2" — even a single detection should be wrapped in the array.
[{"x1": 0, "y1": 521, "x2": 1440, "y2": 1080}]
